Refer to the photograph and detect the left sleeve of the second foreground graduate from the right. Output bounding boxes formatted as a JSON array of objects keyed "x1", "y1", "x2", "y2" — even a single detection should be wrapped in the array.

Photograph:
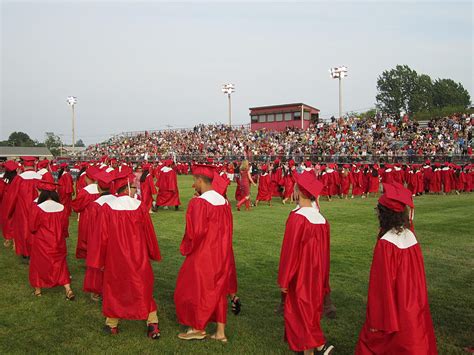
[{"x1": 278, "y1": 213, "x2": 304, "y2": 288}]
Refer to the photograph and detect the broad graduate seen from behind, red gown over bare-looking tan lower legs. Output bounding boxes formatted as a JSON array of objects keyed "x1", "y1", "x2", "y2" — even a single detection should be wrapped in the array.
[{"x1": 88, "y1": 172, "x2": 161, "y2": 339}]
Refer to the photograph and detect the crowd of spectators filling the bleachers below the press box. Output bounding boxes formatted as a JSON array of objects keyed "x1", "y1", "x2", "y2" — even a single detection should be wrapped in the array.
[{"x1": 85, "y1": 114, "x2": 474, "y2": 160}]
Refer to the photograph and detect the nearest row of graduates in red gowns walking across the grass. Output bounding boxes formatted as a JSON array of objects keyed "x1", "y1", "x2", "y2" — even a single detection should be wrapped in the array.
[{"x1": 0, "y1": 157, "x2": 436, "y2": 354}]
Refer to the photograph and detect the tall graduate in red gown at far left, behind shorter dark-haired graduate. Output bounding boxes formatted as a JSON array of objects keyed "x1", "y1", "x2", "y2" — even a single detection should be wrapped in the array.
[{"x1": 5, "y1": 157, "x2": 42, "y2": 259}]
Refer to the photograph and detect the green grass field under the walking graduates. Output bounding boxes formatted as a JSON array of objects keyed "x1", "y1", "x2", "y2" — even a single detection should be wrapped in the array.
[{"x1": 0, "y1": 177, "x2": 474, "y2": 354}]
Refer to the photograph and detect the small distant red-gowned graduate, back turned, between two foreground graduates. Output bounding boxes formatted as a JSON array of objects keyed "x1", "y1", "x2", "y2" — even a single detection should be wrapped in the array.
[{"x1": 156, "y1": 160, "x2": 181, "y2": 210}]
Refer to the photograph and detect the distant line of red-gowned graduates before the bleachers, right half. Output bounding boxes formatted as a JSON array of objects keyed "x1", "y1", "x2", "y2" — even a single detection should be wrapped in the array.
[{"x1": 248, "y1": 159, "x2": 474, "y2": 205}]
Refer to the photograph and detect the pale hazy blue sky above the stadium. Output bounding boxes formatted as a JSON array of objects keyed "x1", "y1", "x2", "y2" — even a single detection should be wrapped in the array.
[{"x1": 0, "y1": 1, "x2": 474, "y2": 143}]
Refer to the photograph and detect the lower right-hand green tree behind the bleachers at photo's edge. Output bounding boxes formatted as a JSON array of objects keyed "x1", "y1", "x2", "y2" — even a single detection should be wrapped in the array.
[{"x1": 433, "y1": 79, "x2": 471, "y2": 108}]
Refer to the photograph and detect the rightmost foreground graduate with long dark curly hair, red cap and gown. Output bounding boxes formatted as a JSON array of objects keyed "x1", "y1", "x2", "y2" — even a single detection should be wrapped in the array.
[{"x1": 355, "y1": 183, "x2": 438, "y2": 355}]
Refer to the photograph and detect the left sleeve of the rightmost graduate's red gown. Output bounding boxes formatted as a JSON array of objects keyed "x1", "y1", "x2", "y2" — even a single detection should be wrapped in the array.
[{"x1": 367, "y1": 240, "x2": 399, "y2": 332}]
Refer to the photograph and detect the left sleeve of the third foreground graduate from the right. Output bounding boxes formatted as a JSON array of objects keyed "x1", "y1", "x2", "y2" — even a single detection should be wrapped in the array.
[{"x1": 179, "y1": 197, "x2": 208, "y2": 255}]
